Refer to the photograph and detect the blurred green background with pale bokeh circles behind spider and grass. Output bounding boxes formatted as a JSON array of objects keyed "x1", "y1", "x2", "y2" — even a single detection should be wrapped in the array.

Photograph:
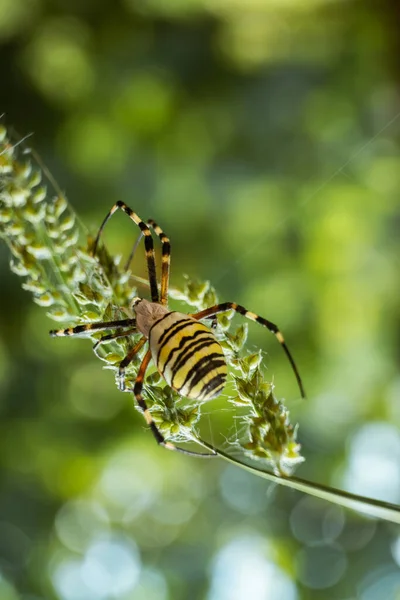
[{"x1": 0, "y1": 0, "x2": 400, "y2": 600}]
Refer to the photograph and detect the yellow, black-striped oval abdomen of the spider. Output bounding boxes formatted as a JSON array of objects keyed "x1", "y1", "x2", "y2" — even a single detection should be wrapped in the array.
[{"x1": 149, "y1": 312, "x2": 227, "y2": 400}]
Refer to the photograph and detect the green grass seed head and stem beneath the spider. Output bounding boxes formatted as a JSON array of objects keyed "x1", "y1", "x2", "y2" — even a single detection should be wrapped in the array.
[{"x1": 0, "y1": 126, "x2": 400, "y2": 522}]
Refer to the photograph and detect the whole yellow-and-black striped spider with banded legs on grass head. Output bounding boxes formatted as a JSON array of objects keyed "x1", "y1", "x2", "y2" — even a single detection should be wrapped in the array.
[{"x1": 50, "y1": 201, "x2": 305, "y2": 456}]
